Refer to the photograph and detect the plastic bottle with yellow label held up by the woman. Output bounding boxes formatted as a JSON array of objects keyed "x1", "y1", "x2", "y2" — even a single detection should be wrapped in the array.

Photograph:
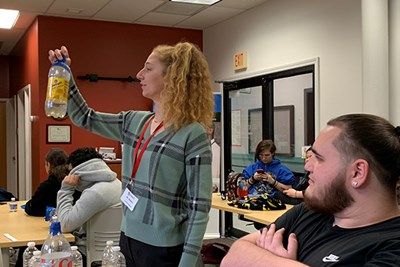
[{"x1": 44, "y1": 57, "x2": 71, "y2": 118}]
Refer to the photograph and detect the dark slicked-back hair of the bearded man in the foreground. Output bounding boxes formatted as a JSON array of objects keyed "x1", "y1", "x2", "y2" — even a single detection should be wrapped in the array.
[{"x1": 328, "y1": 114, "x2": 400, "y2": 188}]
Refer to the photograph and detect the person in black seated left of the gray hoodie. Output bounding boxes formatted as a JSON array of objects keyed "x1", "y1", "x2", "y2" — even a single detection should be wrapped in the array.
[{"x1": 25, "y1": 148, "x2": 69, "y2": 217}]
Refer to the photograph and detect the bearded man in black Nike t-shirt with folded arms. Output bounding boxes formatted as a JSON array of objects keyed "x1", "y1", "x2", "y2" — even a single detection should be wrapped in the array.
[{"x1": 221, "y1": 114, "x2": 400, "y2": 267}]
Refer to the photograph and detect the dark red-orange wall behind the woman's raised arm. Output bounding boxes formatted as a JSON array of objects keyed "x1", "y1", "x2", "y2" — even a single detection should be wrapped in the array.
[{"x1": 11, "y1": 16, "x2": 202, "y2": 191}]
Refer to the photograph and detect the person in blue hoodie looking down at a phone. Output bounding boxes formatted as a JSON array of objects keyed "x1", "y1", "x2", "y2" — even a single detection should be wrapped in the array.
[{"x1": 243, "y1": 139, "x2": 296, "y2": 200}]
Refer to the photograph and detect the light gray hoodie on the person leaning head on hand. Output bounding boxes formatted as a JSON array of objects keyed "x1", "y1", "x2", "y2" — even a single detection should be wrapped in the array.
[{"x1": 56, "y1": 159, "x2": 121, "y2": 232}]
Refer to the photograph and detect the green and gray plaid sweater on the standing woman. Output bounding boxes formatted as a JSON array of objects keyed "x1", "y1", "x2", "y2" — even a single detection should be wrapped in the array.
[{"x1": 68, "y1": 79, "x2": 212, "y2": 267}]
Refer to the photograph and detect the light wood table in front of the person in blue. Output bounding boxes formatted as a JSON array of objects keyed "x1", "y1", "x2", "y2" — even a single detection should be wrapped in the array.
[{"x1": 211, "y1": 193, "x2": 293, "y2": 227}]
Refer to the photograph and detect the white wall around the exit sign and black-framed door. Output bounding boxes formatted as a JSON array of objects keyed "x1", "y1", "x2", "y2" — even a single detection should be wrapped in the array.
[{"x1": 203, "y1": 0, "x2": 362, "y2": 131}]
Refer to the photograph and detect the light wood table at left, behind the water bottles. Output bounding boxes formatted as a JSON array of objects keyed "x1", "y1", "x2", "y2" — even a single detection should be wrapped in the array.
[{"x1": 0, "y1": 201, "x2": 75, "y2": 267}]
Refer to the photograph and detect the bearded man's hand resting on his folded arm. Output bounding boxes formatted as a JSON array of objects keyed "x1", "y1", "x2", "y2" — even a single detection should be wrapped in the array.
[{"x1": 256, "y1": 224, "x2": 298, "y2": 260}]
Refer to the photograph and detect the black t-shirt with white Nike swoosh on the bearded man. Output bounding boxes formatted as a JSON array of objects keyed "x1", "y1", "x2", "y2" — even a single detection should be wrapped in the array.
[{"x1": 275, "y1": 204, "x2": 400, "y2": 267}]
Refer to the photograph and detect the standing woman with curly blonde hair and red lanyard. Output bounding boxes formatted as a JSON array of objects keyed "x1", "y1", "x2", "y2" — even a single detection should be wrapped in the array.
[{"x1": 49, "y1": 42, "x2": 214, "y2": 267}]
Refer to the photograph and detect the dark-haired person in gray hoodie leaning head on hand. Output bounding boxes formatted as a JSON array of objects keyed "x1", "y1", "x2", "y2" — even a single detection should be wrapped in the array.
[{"x1": 56, "y1": 147, "x2": 121, "y2": 253}]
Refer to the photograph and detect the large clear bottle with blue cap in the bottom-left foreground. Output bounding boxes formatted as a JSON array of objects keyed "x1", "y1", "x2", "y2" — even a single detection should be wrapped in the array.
[{"x1": 41, "y1": 216, "x2": 72, "y2": 267}]
